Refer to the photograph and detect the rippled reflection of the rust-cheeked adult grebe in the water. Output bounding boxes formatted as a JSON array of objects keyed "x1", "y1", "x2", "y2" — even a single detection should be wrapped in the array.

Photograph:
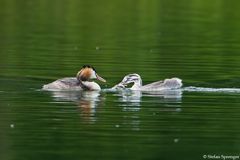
[{"x1": 52, "y1": 91, "x2": 104, "y2": 123}]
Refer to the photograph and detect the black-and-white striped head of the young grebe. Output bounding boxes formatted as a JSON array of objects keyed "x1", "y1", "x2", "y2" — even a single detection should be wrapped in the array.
[{"x1": 121, "y1": 73, "x2": 142, "y2": 86}]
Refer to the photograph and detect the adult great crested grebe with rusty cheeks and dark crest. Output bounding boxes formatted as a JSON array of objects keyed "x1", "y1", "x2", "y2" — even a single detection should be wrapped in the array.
[{"x1": 42, "y1": 65, "x2": 106, "y2": 90}]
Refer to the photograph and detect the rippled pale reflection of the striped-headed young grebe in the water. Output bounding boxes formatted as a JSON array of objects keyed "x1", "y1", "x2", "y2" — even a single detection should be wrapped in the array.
[{"x1": 113, "y1": 88, "x2": 182, "y2": 131}]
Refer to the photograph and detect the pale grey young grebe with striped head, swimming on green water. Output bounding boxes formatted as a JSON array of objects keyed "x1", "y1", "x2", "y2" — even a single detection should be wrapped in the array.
[{"x1": 113, "y1": 73, "x2": 182, "y2": 91}]
